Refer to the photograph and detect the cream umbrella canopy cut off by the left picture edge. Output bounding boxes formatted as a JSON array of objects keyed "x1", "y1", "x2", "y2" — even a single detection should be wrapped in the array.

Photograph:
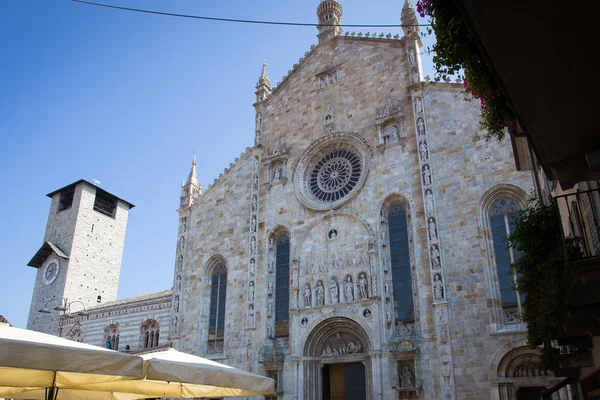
[{"x1": 0, "y1": 324, "x2": 143, "y2": 397}]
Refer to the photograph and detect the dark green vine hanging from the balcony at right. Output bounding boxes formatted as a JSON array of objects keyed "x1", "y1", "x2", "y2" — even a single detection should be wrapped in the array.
[{"x1": 507, "y1": 203, "x2": 566, "y2": 369}]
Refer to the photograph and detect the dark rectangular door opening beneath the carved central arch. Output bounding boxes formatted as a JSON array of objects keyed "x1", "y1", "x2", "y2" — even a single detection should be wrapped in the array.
[{"x1": 323, "y1": 362, "x2": 367, "y2": 400}]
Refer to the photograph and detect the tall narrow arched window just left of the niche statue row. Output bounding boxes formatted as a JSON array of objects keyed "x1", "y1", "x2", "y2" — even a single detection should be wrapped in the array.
[{"x1": 275, "y1": 233, "x2": 290, "y2": 337}]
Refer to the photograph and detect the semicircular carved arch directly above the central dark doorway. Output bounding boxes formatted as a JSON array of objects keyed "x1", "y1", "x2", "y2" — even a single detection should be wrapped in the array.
[{"x1": 303, "y1": 317, "x2": 372, "y2": 357}]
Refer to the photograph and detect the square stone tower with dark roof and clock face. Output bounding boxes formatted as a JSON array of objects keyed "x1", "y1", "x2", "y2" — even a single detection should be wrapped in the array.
[{"x1": 27, "y1": 179, "x2": 134, "y2": 335}]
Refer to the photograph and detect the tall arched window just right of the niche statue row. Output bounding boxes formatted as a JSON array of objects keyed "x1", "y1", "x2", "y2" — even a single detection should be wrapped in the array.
[{"x1": 387, "y1": 203, "x2": 415, "y2": 322}]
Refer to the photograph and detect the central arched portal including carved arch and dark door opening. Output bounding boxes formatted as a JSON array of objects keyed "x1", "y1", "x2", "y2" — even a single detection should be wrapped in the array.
[{"x1": 303, "y1": 317, "x2": 373, "y2": 400}]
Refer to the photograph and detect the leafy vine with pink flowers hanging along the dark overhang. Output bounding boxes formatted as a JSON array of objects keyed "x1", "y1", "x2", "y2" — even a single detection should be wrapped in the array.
[{"x1": 417, "y1": 0, "x2": 515, "y2": 140}]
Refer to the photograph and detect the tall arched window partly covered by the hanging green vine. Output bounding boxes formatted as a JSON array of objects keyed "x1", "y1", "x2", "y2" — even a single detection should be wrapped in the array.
[{"x1": 488, "y1": 197, "x2": 523, "y2": 324}]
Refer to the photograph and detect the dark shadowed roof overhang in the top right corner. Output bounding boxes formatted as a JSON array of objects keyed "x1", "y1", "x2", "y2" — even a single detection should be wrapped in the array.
[{"x1": 458, "y1": 0, "x2": 600, "y2": 188}]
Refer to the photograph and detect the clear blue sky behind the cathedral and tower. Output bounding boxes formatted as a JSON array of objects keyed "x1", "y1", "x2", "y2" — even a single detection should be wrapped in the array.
[{"x1": 0, "y1": 0, "x2": 433, "y2": 327}]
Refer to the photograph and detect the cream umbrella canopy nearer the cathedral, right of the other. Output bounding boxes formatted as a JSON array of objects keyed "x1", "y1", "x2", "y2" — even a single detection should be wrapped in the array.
[{"x1": 75, "y1": 349, "x2": 275, "y2": 400}]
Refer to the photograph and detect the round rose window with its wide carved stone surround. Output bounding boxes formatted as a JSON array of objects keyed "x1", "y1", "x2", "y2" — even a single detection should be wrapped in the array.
[{"x1": 294, "y1": 133, "x2": 370, "y2": 210}]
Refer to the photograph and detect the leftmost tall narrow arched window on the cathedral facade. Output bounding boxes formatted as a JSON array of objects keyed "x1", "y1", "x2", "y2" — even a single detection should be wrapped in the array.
[{"x1": 208, "y1": 263, "x2": 227, "y2": 353}]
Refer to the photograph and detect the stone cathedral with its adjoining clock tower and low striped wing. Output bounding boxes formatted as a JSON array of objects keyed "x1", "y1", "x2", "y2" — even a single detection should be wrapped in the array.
[{"x1": 23, "y1": 0, "x2": 566, "y2": 400}]
